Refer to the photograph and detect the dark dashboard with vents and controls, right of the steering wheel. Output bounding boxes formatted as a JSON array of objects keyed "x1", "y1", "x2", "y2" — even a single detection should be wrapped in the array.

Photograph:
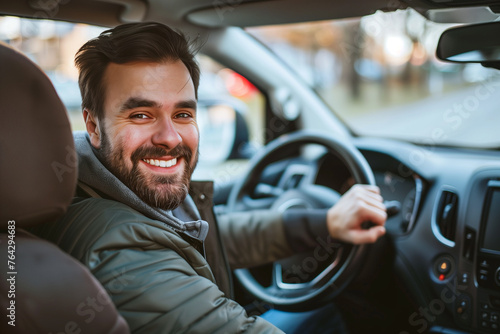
[{"x1": 357, "y1": 140, "x2": 500, "y2": 333}]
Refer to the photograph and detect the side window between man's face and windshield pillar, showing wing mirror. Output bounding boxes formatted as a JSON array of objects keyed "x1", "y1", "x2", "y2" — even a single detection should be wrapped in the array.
[{"x1": 194, "y1": 55, "x2": 266, "y2": 182}]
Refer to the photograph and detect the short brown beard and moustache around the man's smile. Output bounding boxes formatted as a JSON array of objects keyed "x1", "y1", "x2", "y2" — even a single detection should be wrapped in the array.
[{"x1": 98, "y1": 132, "x2": 199, "y2": 210}]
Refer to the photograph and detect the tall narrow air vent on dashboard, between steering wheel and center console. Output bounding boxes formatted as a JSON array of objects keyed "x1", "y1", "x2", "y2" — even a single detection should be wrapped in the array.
[{"x1": 436, "y1": 190, "x2": 458, "y2": 241}]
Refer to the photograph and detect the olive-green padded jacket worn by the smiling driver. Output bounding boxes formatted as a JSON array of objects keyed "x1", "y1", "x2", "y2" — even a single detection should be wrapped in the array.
[{"x1": 36, "y1": 182, "x2": 292, "y2": 333}]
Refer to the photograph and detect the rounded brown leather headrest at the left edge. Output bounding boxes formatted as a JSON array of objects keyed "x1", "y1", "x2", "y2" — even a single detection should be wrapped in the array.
[{"x1": 0, "y1": 44, "x2": 77, "y2": 230}]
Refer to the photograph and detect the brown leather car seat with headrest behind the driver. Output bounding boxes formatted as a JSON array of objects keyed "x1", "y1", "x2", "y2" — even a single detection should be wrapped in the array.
[{"x1": 0, "y1": 42, "x2": 129, "y2": 334}]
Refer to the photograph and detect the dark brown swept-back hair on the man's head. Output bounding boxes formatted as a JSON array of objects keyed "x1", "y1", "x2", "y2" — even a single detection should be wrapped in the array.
[{"x1": 75, "y1": 22, "x2": 200, "y2": 119}]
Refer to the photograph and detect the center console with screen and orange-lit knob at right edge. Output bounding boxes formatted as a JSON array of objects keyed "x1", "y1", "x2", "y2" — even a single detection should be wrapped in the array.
[{"x1": 432, "y1": 176, "x2": 500, "y2": 334}]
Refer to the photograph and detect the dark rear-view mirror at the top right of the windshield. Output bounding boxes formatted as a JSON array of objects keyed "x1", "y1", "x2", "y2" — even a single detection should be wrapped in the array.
[{"x1": 436, "y1": 22, "x2": 500, "y2": 69}]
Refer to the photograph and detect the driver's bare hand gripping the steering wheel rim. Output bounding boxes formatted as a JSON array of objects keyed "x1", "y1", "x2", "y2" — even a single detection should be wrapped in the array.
[{"x1": 326, "y1": 184, "x2": 387, "y2": 244}]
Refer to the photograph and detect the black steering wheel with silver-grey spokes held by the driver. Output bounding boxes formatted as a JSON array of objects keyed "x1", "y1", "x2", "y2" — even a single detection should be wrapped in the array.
[{"x1": 227, "y1": 131, "x2": 375, "y2": 311}]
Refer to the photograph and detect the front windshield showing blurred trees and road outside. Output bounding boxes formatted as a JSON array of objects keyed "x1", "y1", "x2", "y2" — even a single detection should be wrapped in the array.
[{"x1": 247, "y1": 10, "x2": 500, "y2": 148}]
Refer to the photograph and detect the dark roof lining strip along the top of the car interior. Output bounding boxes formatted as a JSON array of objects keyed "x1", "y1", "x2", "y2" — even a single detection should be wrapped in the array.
[{"x1": 0, "y1": 0, "x2": 498, "y2": 30}]
